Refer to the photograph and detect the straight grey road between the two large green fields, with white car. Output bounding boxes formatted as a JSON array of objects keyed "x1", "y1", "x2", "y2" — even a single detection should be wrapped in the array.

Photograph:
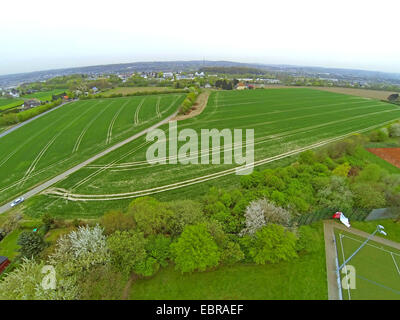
[{"x1": 0, "y1": 112, "x2": 178, "y2": 214}]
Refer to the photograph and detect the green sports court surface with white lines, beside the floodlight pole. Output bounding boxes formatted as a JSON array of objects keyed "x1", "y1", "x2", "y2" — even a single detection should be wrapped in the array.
[{"x1": 335, "y1": 231, "x2": 400, "y2": 300}]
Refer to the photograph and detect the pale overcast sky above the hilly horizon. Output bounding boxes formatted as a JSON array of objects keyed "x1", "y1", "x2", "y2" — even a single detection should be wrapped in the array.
[{"x1": 0, "y1": 0, "x2": 400, "y2": 74}]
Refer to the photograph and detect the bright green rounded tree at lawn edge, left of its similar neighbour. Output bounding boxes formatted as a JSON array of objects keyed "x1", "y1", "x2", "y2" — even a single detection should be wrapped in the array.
[{"x1": 171, "y1": 224, "x2": 220, "y2": 272}]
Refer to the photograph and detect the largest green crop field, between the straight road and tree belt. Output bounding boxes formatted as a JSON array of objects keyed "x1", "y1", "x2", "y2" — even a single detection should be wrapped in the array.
[{"x1": 23, "y1": 88, "x2": 400, "y2": 217}]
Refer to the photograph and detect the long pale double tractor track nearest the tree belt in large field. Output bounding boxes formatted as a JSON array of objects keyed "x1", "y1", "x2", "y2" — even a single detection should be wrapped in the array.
[{"x1": 45, "y1": 121, "x2": 400, "y2": 201}]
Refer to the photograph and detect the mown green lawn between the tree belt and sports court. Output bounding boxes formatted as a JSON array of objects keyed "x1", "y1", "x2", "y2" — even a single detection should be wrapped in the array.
[{"x1": 130, "y1": 223, "x2": 327, "y2": 300}]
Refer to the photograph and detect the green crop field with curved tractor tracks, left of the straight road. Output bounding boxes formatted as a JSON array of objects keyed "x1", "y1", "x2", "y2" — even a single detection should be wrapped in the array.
[{"x1": 0, "y1": 95, "x2": 184, "y2": 203}]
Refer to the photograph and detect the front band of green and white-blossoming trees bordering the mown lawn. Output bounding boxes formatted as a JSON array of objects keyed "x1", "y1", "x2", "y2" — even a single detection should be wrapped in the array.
[{"x1": 0, "y1": 192, "x2": 318, "y2": 299}]
